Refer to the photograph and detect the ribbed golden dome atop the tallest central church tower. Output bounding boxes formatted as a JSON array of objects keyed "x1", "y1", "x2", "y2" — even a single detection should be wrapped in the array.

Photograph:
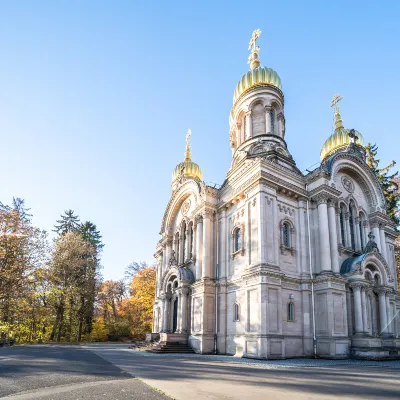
[{"x1": 233, "y1": 66, "x2": 282, "y2": 104}]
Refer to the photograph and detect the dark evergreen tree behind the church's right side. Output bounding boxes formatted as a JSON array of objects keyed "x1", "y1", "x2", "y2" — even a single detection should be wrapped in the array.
[{"x1": 365, "y1": 143, "x2": 400, "y2": 227}]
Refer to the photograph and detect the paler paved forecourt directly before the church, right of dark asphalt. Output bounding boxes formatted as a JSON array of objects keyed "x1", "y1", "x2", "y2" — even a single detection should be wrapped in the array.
[{"x1": 88, "y1": 345, "x2": 400, "y2": 400}]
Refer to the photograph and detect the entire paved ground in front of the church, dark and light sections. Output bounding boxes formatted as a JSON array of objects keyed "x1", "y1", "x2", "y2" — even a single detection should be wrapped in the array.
[{"x1": 0, "y1": 344, "x2": 400, "y2": 400}]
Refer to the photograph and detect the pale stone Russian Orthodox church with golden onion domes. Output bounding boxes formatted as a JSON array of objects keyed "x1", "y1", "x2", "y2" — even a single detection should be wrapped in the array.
[{"x1": 151, "y1": 30, "x2": 400, "y2": 359}]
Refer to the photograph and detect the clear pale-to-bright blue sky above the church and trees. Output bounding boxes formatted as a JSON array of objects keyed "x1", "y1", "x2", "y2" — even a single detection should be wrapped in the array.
[{"x1": 0, "y1": 0, "x2": 400, "y2": 278}]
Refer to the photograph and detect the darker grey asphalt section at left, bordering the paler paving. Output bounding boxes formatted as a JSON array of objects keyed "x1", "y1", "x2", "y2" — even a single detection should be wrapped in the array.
[{"x1": 0, "y1": 346, "x2": 167, "y2": 400}]
